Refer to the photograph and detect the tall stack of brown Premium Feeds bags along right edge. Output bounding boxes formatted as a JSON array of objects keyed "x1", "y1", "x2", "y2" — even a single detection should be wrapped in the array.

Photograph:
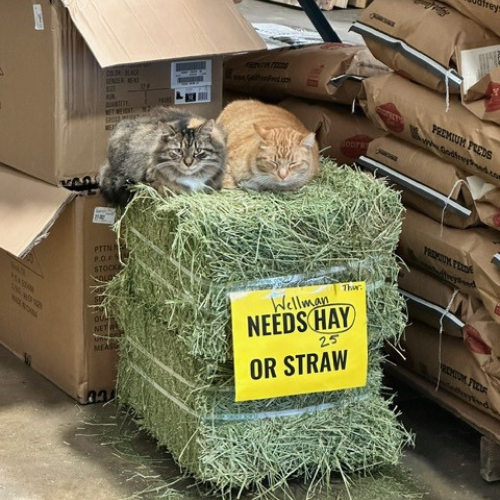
[{"x1": 353, "y1": 0, "x2": 500, "y2": 424}]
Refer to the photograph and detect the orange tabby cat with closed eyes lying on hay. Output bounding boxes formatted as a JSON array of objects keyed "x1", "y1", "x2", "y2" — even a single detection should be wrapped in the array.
[{"x1": 217, "y1": 99, "x2": 319, "y2": 191}]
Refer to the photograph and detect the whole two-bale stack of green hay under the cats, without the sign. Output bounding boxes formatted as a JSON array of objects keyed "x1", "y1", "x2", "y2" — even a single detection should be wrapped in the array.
[{"x1": 104, "y1": 160, "x2": 408, "y2": 492}]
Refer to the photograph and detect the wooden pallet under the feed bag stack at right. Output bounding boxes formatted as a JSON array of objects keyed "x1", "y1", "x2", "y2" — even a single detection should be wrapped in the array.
[{"x1": 385, "y1": 363, "x2": 500, "y2": 482}]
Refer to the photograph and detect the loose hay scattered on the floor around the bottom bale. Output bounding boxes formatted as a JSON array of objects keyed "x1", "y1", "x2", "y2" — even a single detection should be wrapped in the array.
[{"x1": 75, "y1": 402, "x2": 424, "y2": 500}]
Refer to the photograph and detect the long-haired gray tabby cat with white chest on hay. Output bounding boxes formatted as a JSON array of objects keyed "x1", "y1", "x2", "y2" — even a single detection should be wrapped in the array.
[{"x1": 99, "y1": 107, "x2": 226, "y2": 207}]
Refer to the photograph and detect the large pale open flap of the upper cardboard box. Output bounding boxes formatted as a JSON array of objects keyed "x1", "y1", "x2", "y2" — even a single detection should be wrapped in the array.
[{"x1": 62, "y1": 0, "x2": 266, "y2": 68}]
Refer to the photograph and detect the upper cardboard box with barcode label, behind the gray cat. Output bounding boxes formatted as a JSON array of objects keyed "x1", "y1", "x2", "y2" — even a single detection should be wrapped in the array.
[{"x1": 0, "y1": 0, "x2": 265, "y2": 185}]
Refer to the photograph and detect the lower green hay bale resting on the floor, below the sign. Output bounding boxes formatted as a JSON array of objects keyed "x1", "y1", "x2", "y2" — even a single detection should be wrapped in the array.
[{"x1": 118, "y1": 304, "x2": 406, "y2": 491}]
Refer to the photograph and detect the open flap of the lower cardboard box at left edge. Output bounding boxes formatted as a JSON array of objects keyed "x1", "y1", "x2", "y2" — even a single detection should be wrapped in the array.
[{"x1": 0, "y1": 164, "x2": 76, "y2": 258}]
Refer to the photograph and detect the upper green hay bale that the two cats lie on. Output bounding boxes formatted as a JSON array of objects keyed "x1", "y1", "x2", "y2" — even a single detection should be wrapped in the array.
[{"x1": 106, "y1": 160, "x2": 403, "y2": 362}]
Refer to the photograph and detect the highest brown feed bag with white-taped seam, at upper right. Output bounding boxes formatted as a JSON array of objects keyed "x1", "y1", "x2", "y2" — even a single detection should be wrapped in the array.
[{"x1": 351, "y1": 0, "x2": 500, "y2": 95}]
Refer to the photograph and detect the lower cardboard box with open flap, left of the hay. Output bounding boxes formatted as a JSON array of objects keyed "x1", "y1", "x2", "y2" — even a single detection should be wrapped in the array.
[{"x1": 0, "y1": 166, "x2": 123, "y2": 403}]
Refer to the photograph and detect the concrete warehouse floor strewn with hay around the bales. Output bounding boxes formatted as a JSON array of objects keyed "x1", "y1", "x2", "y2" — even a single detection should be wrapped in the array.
[{"x1": 0, "y1": 0, "x2": 500, "y2": 500}]
